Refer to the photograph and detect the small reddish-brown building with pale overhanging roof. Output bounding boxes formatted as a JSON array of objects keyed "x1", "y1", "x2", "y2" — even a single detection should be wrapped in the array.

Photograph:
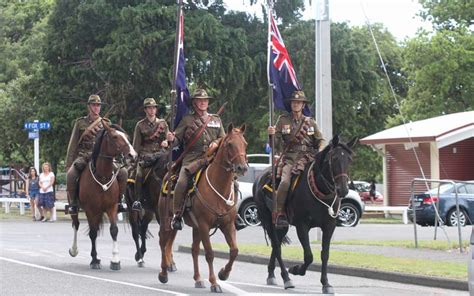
[{"x1": 360, "y1": 111, "x2": 474, "y2": 206}]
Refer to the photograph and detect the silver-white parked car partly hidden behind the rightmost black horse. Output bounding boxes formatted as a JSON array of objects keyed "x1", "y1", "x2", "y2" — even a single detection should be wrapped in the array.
[{"x1": 236, "y1": 154, "x2": 365, "y2": 230}]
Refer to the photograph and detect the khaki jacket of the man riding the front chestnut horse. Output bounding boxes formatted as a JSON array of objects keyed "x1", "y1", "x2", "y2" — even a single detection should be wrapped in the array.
[{"x1": 175, "y1": 114, "x2": 225, "y2": 166}]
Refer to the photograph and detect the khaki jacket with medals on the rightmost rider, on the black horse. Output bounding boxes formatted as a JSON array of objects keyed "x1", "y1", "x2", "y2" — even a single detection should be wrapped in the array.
[{"x1": 275, "y1": 113, "x2": 324, "y2": 163}]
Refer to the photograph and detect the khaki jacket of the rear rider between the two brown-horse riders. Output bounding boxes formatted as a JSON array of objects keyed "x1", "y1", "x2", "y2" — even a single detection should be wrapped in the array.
[{"x1": 133, "y1": 117, "x2": 169, "y2": 159}]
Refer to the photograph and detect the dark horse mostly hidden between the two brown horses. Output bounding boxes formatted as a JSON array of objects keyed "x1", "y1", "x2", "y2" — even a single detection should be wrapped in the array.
[{"x1": 126, "y1": 151, "x2": 173, "y2": 271}]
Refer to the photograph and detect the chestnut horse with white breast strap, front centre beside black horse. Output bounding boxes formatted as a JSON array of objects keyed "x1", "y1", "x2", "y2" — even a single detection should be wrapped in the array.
[{"x1": 158, "y1": 124, "x2": 248, "y2": 292}]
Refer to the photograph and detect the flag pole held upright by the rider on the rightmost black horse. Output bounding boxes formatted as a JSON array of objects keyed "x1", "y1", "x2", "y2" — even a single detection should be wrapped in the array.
[{"x1": 267, "y1": 0, "x2": 277, "y2": 213}]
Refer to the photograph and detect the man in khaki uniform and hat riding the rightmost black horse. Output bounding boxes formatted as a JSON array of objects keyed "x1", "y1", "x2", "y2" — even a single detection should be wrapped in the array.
[{"x1": 268, "y1": 91, "x2": 324, "y2": 228}]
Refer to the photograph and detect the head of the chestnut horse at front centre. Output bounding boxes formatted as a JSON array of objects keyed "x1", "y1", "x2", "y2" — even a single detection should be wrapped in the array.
[{"x1": 219, "y1": 123, "x2": 248, "y2": 176}]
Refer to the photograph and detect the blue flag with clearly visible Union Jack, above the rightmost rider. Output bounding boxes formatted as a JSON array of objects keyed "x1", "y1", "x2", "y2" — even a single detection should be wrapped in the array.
[{"x1": 268, "y1": 11, "x2": 311, "y2": 116}]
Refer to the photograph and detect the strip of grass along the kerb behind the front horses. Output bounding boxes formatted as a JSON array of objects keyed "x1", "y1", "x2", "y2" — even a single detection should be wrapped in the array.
[{"x1": 213, "y1": 243, "x2": 467, "y2": 280}]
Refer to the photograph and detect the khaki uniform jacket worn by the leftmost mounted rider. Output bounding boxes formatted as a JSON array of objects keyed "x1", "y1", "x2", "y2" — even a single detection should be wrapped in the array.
[{"x1": 66, "y1": 115, "x2": 108, "y2": 168}]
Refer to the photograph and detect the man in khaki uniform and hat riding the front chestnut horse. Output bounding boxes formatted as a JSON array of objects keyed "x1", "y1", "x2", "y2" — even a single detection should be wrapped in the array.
[{"x1": 171, "y1": 89, "x2": 225, "y2": 230}]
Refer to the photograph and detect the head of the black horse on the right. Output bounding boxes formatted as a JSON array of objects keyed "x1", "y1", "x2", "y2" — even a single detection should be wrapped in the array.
[{"x1": 320, "y1": 135, "x2": 358, "y2": 197}]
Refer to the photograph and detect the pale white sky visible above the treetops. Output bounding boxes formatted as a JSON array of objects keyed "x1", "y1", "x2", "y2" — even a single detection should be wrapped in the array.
[{"x1": 224, "y1": 0, "x2": 431, "y2": 41}]
